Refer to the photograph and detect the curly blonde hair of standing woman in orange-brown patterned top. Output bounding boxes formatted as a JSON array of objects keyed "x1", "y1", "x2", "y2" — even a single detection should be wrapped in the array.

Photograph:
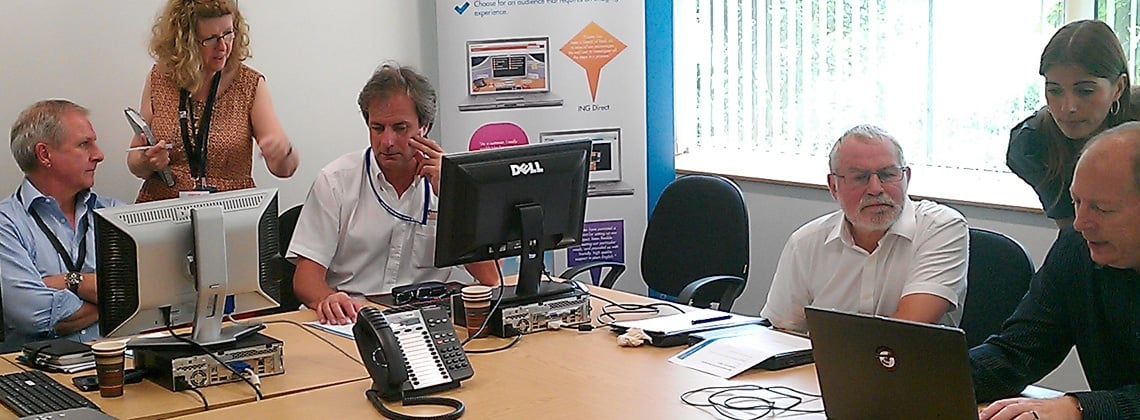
[{"x1": 150, "y1": 0, "x2": 250, "y2": 92}]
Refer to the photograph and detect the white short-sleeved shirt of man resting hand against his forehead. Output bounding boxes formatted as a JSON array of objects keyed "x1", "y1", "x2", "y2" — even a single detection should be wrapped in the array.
[{"x1": 286, "y1": 151, "x2": 451, "y2": 297}]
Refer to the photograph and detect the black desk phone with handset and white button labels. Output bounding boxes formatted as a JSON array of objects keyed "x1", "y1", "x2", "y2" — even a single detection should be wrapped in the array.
[{"x1": 352, "y1": 306, "x2": 475, "y2": 419}]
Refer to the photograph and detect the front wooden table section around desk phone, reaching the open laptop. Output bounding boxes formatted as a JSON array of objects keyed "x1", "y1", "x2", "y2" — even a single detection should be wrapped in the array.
[{"x1": 173, "y1": 288, "x2": 823, "y2": 419}]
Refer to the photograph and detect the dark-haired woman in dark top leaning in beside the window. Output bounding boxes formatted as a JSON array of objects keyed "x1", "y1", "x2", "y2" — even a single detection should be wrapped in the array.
[{"x1": 1005, "y1": 21, "x2": 1140, "y2": 229}]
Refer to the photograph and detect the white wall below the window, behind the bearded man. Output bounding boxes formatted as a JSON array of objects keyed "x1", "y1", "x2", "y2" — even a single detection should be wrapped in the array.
[{"x1": 733, "y1": 181, "x2": 1089, "y2": 390}]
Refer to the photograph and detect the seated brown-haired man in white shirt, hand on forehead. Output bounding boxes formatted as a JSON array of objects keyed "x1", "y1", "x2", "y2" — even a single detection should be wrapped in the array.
[{"x1": 287, "y1": 64, "x2": 498, "y2": 324}]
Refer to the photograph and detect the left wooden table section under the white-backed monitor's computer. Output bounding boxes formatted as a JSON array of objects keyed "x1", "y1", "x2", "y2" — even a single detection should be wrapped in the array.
[{"x1": 0, "y1": 310, "x2": 368, "y2": 419}]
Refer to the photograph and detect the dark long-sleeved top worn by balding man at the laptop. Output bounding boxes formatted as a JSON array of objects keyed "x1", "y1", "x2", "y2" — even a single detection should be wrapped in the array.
[{"x1": 970, "y1": 231, "x2": 1140, "y2": 419}]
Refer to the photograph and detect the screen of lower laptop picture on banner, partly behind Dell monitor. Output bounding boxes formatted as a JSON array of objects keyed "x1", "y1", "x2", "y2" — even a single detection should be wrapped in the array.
[{"x1": 539, "y1": 128, "x2": 634, "y2": 196}]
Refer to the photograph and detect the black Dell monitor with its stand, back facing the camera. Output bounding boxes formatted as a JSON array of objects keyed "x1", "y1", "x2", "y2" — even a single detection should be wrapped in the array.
[{"x1": 435, "y1": 139, "x2": 591, "y2": 301}]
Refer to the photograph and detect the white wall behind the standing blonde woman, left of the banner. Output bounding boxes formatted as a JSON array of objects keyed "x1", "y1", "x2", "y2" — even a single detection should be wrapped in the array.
[{"x1": 0, "y1": 0, "x2": 438, "y2": 210}]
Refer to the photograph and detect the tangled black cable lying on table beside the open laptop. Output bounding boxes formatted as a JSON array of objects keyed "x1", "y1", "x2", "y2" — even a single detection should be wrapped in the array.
[{"x1": 681, "y1": 385, "x2": 823, "y2": 420}]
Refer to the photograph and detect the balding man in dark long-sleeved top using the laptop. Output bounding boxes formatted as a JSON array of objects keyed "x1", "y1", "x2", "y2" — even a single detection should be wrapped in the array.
[{"x1": 970, "y1": 122, "x2": 1140, "y2": 420}]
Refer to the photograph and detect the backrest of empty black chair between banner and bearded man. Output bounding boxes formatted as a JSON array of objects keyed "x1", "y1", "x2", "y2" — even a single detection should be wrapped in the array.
[{"x1": 641, "y1": 175, "x2": 749, "y2": 305}]
